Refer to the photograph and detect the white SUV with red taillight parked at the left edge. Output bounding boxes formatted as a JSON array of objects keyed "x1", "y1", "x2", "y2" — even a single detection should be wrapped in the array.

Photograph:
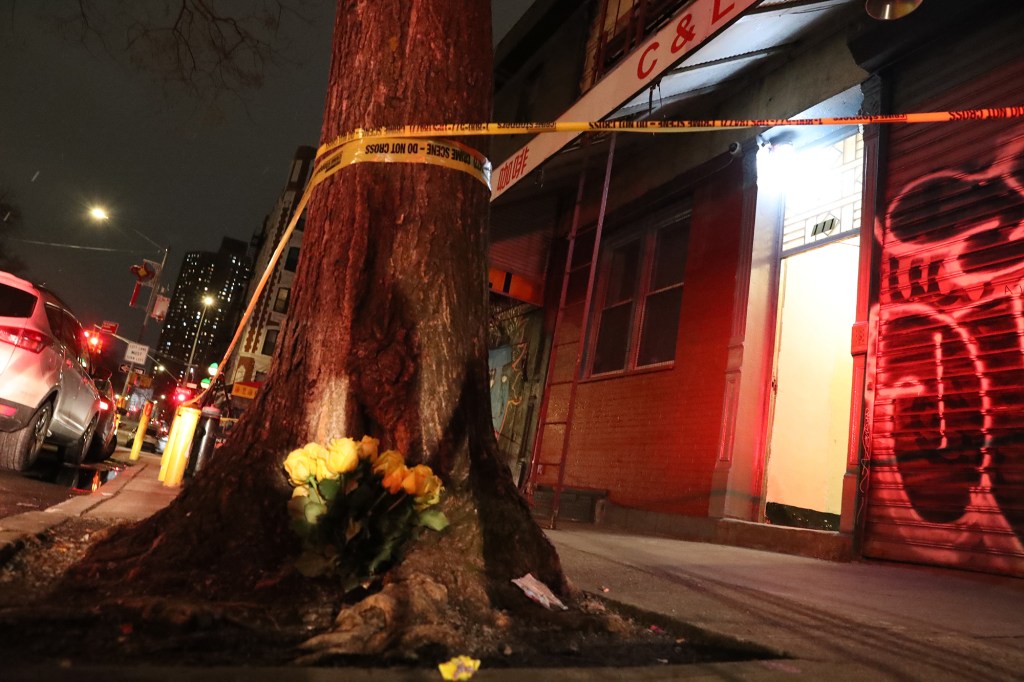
[{"x1": 0, "y1": 271, "x2": 99, "y2": 471}]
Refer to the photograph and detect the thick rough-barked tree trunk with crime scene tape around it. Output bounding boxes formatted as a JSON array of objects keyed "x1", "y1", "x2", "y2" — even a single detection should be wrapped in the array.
[{"x1": 73, "y1": 0, "x2": 565, "y2": 653}]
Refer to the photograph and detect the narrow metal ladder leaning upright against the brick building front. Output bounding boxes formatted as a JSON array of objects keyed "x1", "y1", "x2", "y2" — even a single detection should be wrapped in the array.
[{"x1": 526, "y1": 135, "x2": 615, "y2": 528}]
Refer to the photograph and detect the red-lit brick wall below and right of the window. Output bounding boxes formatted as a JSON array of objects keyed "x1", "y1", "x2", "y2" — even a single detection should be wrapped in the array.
[{"x1": 537, "y1": 164, "x2": 741, "y2": 516}]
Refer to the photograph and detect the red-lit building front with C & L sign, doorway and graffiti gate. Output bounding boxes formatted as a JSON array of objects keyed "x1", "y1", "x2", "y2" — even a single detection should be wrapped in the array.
[{"x1": 490, "y1": 0, "x2": 1024, "y2": 576}]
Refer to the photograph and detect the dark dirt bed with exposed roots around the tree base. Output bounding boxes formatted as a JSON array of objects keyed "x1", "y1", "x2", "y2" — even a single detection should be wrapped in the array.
[{"x1": 0, "y1": 519, "x2": 772, "y2": 668}]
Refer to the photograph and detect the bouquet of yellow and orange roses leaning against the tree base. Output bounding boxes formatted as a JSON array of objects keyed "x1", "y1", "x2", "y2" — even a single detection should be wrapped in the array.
[{"x1": 285, "y1": 436, "x2": 449, "y2": 592}]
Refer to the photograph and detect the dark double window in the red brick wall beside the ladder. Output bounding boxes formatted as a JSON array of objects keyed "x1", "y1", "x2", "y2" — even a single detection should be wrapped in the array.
[{"x1": 590, "y1": 212, "x2": 689, "y2": 375}]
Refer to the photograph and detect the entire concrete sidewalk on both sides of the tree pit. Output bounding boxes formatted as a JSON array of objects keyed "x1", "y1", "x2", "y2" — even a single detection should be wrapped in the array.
[{"x1": 0, "y1": 450, "x2": 1024, "y2": 682}]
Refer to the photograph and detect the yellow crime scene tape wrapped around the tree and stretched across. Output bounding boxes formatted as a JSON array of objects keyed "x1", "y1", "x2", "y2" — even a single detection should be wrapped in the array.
[{"x1": 189, "y1": 102, "x2": 1024, "y2": 403}]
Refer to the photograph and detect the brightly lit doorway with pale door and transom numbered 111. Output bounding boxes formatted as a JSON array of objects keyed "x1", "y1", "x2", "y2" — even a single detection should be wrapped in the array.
[{"x1": 764, "y1": 132, "x2": 863, "y2": 530}]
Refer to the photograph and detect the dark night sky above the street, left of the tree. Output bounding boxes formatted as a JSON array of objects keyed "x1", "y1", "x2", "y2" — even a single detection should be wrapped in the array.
[{"x1": 0, "y1": 0, "x2": 529, "y2": 344}]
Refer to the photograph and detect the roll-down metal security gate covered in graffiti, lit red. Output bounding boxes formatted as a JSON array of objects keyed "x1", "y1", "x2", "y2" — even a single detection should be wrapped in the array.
[{"x1": 862, "y1": 22, "x2": 1024, "y2": 577}]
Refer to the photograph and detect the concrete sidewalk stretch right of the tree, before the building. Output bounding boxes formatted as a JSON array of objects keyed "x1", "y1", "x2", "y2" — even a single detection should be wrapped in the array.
[{"x1": 549, "y1": 529, "x2": 1024, "y2": 680}]
